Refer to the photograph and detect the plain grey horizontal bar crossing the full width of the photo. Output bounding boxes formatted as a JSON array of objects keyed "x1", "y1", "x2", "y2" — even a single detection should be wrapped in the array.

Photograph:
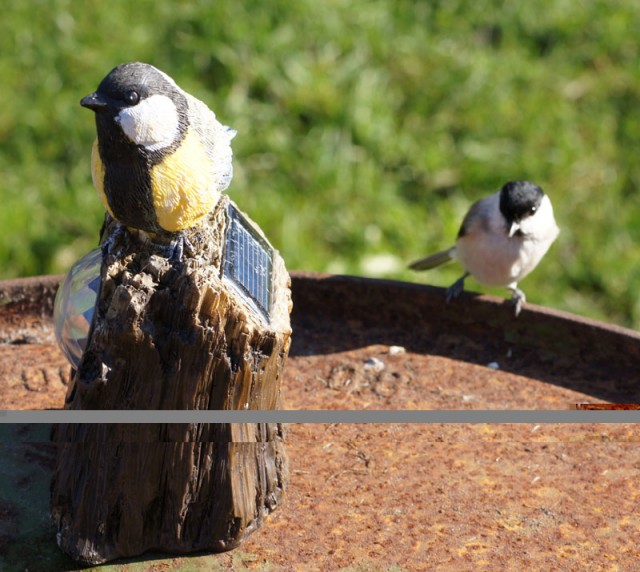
[{"x1": 0, "y1": 409, "x2": 640, "y2": 423}]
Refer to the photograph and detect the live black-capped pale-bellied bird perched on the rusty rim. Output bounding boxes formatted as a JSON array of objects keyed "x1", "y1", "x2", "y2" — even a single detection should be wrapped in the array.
[{"x1": 409, "y1": 181, "x2": 560, "y2": 316}]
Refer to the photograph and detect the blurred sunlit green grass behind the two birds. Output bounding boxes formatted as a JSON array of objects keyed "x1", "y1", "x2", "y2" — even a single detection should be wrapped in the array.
[{"x1": 0, "y1": 0, "x2": 640, "y2": 328}]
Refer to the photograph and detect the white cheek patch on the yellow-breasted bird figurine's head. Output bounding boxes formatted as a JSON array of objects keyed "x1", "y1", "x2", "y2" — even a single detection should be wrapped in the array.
[{"x1": 116, "y1": 95, "x2": 178, "y2": 151}]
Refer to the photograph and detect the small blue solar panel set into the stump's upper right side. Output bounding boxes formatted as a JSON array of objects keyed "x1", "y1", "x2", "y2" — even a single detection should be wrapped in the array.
[{"x1": 222, "y1": 203, "x2": 273, "y2": 322}]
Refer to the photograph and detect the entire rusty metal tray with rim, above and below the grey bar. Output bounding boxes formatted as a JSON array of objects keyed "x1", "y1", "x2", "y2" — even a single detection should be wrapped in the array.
[{"x1": 0, "y1": 274, "x2": 640, "y2": 572}]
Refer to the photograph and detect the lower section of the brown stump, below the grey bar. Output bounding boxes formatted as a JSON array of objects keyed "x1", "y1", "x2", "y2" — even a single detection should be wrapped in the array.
[{"x1": 52, "y1": 423, "x2": 287, "y2": 564}]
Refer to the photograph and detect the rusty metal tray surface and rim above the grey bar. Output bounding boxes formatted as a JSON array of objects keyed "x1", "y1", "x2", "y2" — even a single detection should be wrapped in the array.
[{"x1": 0, "y1": 273, "x2": 640, "y2": 409}]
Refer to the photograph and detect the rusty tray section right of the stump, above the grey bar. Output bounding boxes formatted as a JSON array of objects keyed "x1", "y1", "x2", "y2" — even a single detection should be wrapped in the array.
[{"x1": 287, "y1": 275, "x2": 640, "y2": 409}]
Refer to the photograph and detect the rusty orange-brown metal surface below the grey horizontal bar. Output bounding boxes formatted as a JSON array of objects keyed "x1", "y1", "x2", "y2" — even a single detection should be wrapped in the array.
[{"x1": 0, "y1": 424, "x2": 640, "y2": 572}]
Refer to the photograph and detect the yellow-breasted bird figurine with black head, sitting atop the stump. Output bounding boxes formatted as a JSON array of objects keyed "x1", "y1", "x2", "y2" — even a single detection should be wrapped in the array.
[{"x1": 80, "y1": 62, "x2": 236, "y2": 258}]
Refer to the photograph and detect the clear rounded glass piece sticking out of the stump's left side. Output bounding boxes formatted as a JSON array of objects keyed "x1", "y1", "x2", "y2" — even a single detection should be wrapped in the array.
[{"x1": 53, "y1": 248, "x2": 102, "y2": 368}]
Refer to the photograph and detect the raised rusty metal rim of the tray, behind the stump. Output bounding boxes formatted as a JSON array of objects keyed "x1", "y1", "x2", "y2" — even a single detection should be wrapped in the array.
[{"x1": 0, "y1": 272, "x2": 640, "y2": 403}]
